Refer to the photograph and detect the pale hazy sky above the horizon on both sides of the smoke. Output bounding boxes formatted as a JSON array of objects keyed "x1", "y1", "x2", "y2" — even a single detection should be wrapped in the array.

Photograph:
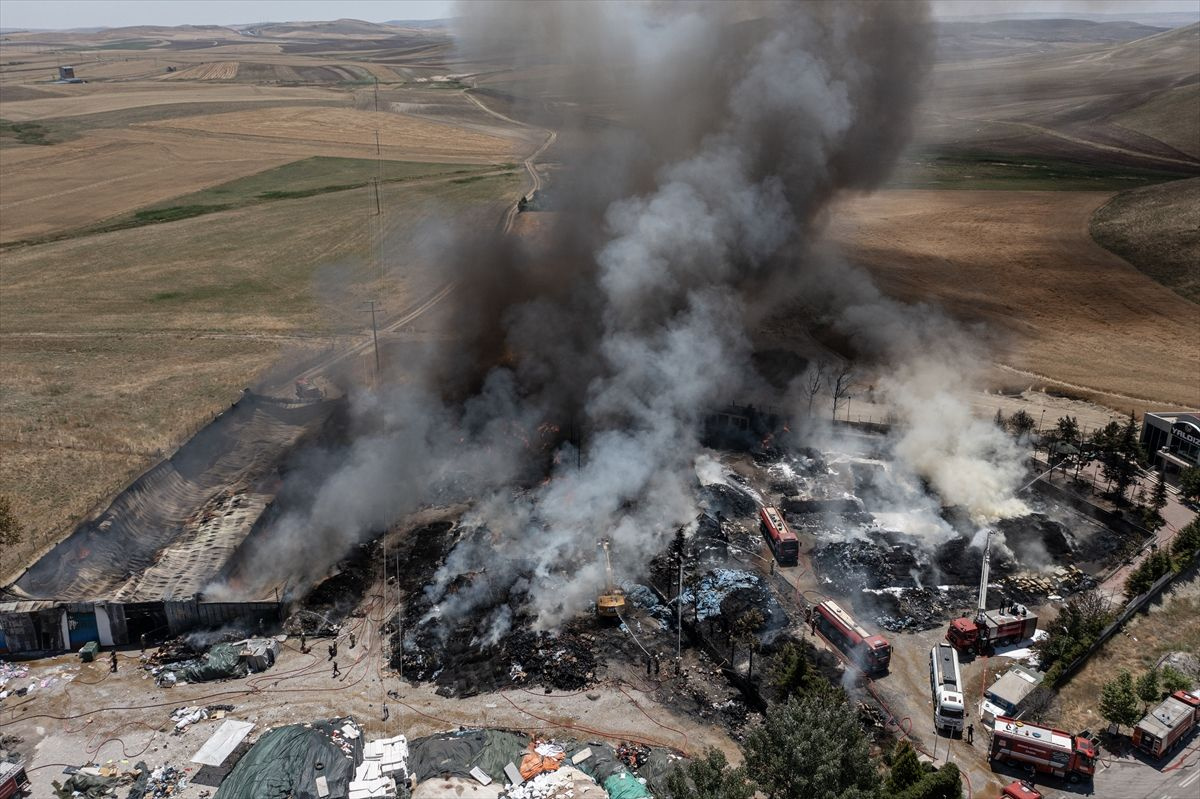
[{"x1": 0, "y1": 0, "x2": 1196, "y2": 28}]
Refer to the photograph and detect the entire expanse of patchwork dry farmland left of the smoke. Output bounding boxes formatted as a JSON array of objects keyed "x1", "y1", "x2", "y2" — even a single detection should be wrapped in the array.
[{"x1": 0, "y1": 20, "x2": 541, "y2": 572}]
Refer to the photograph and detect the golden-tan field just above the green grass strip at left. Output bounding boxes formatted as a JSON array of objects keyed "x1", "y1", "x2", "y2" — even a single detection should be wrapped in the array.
[{"x1": 0, "y1": 97, "x2": 524, "y2": 242}]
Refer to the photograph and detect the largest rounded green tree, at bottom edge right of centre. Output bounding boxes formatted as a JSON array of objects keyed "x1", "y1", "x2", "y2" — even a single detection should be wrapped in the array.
[{"x1": 745, "y1": 696, "x2": 880, "y2": 799}]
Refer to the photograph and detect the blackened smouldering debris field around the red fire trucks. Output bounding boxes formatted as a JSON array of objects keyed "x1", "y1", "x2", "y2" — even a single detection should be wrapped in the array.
[{"x1": 274, "y1": 422, "x2": 1126, "y2": 729}]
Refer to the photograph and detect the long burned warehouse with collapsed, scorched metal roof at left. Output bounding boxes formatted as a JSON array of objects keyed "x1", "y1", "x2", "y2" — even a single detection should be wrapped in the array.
[{"x1": 0, "y1": 391, "x2": 335, "y2": 653}]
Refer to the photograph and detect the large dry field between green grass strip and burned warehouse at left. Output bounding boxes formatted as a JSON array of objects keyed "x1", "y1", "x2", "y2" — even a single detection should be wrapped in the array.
[{"x1": 0, "y1": 170, "x2": 522, "y2": 572}]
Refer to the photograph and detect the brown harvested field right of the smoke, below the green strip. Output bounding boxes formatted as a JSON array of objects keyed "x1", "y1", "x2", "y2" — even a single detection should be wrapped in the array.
[{"x1": 832, "y1": 191, "x2": 1200, "y2": 408}]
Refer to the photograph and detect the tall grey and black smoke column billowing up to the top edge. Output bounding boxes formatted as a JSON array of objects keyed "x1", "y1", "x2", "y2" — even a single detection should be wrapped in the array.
[{"x1": 216, "y1": 0, "x2": 984, "y2": 630}]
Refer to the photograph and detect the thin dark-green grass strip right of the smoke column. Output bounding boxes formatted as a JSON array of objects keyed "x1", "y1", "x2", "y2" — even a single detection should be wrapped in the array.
[{"x1": 888, "y1": 152, "x2": 1192, "y2": 192}]
